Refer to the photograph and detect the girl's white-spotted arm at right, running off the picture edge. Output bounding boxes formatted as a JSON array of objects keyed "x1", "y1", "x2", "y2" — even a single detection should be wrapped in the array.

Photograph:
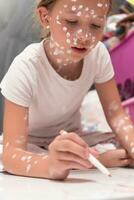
[{"x1": 95, "y1": 79, "x2": 134, "y2": 158}]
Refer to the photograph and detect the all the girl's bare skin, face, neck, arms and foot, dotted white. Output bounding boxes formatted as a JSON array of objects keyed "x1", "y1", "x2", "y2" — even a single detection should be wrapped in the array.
[{"x1": 3, "y1": 0, "x2": 134, "y2": 179}]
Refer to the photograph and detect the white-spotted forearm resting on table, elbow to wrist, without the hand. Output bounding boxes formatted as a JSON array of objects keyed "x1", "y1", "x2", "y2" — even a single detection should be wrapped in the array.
[{"x1": 3, "y1": 147, "x2": 49, "y2": 178}]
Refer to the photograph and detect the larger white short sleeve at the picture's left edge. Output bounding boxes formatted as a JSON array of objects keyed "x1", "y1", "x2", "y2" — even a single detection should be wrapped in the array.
[{"x1": 0, "y1": 57, "x2": 36, "y2": 107}]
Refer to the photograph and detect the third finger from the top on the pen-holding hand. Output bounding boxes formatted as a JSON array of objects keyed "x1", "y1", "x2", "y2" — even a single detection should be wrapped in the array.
[{"x1": 57, "y1": 152, "x2": 92, "y2": 168}]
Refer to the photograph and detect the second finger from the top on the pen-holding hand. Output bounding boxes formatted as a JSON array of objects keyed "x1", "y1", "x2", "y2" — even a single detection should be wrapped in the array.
[{"x1": 55, "y1": 140, "x2": 89, "y2": 159}]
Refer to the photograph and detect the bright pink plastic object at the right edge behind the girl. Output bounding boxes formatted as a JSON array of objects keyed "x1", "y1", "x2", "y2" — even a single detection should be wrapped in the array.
[{"x1": 110, "y1": 31, "x2": 134, "y2": 122}]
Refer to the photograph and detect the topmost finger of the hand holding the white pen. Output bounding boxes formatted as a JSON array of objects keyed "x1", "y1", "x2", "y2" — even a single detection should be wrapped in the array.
[{"x1": 59, "y1": 130, "x2": 88, "y2": 147}]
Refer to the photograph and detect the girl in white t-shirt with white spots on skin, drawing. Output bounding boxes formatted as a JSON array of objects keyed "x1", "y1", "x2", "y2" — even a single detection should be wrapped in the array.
[{"x1": 1, "y1": 0, "x2": 134, "y2": 179}]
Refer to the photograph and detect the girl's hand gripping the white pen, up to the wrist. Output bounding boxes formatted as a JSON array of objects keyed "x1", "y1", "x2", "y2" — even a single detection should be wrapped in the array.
[{"x1": 48, "y1": 133, "x2": 97, "y2": 179}]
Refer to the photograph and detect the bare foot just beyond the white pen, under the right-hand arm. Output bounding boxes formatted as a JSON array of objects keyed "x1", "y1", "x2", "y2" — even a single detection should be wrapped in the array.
[{"x1": 98, "y1": 149, "x2": 131, "y2": 167}]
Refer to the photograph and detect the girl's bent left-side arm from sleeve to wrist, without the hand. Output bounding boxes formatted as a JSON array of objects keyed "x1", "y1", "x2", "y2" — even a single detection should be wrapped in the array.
[{"x1": 3, "y1": 100, "x2": 48, "y2": 178}]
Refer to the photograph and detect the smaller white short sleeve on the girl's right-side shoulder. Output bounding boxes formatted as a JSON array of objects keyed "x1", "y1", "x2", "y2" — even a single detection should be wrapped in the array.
[{"x1": 94, "y1": 43, "x2": 114, "y2": 83}]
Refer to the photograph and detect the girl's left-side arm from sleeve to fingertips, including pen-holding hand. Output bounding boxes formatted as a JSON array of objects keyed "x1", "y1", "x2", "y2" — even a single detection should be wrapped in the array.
[{"x1": 3, "y1": 100, "x2": 94, "y2": 179}]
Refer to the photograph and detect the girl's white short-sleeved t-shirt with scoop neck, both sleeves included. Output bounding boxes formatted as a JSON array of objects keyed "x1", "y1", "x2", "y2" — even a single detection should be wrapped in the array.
[{"x1": 0, "y1": 41, "x2": 114, "y2": 145}]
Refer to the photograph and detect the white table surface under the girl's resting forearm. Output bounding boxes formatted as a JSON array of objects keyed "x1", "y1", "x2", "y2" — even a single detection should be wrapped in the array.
[{"x1": 0, "y1": 168, "x2": 134, "y2": 200}]
